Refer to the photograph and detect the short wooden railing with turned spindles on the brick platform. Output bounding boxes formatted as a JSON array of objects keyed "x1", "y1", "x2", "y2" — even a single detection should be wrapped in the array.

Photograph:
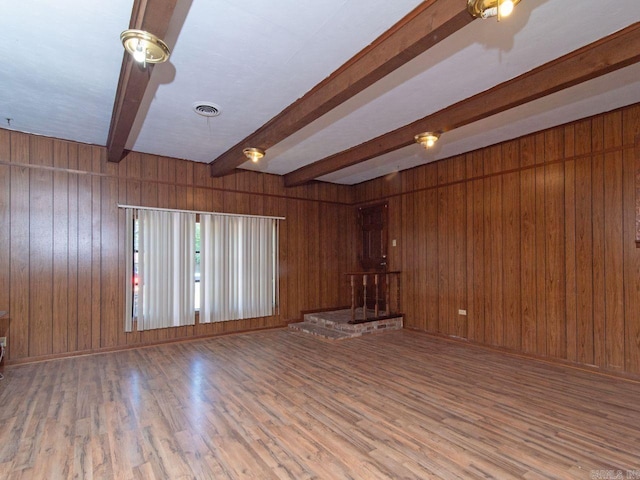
[{"x1": 347, "y1": 271, "x2": 400, "y2": 323}]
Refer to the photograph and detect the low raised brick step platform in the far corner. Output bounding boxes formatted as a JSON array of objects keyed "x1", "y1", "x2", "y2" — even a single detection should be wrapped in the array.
[{"x1": 289, "y1": 310, "x2": 403, "y2": 340}]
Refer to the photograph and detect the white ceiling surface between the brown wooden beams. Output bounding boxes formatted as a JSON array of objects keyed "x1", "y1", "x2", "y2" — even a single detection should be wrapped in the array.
[{"x1": 0, "y1": 0, "x2": 640, "y2": 184}]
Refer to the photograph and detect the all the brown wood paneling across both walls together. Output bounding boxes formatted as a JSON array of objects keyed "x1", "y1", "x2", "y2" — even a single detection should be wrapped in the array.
[{"x1": 0, "y1": 105, "x2": 640, "y2": 373}]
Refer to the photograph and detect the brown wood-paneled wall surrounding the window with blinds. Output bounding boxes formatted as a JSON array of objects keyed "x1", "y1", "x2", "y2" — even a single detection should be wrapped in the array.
[{"x1": 0, "y1": 130, "x2": 355, "y2": 362}]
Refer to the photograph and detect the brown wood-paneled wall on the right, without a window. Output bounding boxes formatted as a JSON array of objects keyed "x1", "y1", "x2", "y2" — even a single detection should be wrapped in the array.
[{"x1": 354, "y1": 105, "x2": 640, "y2": 374}]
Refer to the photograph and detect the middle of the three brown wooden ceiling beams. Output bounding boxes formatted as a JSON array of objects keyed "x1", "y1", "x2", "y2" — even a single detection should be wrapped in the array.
[{"x1": 210, "y1": 0, "x2": 473, "y2": 177}]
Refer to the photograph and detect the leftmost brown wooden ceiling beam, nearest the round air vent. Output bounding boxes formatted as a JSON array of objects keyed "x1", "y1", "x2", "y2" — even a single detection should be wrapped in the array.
[{"x1": 107, "y1": 0, "x2": 177, "y2": 162}]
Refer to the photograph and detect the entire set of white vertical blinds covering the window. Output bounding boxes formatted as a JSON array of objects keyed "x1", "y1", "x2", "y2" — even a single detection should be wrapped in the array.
[{"x1": 125, "y1": 207, "x2": 279, "y2": 332}]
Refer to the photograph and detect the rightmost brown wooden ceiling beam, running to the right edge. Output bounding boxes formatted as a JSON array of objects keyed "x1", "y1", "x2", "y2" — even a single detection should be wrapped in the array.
[{"x1": 284, "y1": 23, "x2": 640, "y2": 187}]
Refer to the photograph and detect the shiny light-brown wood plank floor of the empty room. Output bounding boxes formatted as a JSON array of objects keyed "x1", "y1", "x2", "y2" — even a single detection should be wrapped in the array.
[{"x1": 0, "y1": 329, "x2": 640, "y2": 479}]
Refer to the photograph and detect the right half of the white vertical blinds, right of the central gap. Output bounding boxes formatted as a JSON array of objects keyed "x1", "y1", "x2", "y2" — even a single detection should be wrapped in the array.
[{"x1": 200, "y1": 214, "x2": 278, "y2": 323}]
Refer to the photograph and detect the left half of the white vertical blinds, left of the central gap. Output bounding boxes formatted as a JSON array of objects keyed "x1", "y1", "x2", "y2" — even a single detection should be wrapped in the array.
[{"x1": 138, "y1": 210, "x2": 196, "y2": 330}]
